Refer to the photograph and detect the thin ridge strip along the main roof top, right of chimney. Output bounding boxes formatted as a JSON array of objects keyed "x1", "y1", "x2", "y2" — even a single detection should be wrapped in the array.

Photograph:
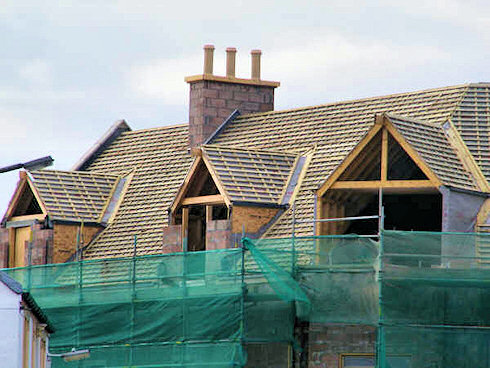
[{"x1": 236, "y1": 83, "x2": 471, "y2": 120}]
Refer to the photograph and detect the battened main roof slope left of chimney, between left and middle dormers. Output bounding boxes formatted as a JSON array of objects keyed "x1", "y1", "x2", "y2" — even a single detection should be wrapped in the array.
[{"x1": 84, "y1": 124, "x2": 192, "y2": 258}]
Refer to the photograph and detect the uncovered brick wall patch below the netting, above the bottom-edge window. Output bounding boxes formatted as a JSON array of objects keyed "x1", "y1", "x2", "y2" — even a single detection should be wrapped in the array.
[{"x1": 308, "y1": 324, "x2": 376, "y2": 368}]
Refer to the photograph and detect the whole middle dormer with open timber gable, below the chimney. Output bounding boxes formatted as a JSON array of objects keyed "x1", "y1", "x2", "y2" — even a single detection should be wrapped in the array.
[{"x1": 164, "y1": 145, "x2": 308, "y2": 251}]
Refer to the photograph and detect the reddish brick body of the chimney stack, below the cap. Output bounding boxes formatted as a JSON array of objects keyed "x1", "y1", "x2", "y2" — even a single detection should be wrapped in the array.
[{"x1": 189, "y1": 80, "x2": 274, "y2": 147}]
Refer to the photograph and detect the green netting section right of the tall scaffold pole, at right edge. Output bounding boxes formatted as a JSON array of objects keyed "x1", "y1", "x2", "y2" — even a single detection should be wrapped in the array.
[{"x1": 378, "y1": 231, "x2": 490, "y2": 368}]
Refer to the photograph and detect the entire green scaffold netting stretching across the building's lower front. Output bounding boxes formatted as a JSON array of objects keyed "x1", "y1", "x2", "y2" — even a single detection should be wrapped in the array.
[{"x1": 5, "y1": 231, "x2": 490, "y2": 368}]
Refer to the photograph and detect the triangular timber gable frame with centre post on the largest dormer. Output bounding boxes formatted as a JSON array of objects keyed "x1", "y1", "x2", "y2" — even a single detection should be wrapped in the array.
[{"x1": 317, "y1": 113, "x2": 442, "y2": 200}]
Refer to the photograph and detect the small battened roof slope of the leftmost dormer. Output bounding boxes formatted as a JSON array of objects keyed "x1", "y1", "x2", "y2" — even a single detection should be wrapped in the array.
[{"x1": 30, "y1": 170, "x2": 118, "y2": 222}]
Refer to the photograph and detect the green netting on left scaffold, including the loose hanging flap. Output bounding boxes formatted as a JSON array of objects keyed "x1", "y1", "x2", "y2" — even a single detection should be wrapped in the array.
[{"x1": 4, "y1": 240, "x2": 308, "y2": 367}]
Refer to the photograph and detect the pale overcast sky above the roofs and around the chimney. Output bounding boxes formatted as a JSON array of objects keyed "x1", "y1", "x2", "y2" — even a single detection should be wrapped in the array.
[{"x1": 0, "y1": 0, "x2": 490, "y2": 214}]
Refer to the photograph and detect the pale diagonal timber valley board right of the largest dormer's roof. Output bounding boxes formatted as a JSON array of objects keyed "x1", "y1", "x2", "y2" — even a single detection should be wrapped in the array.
[{"x1": 442, "y1": 120, "x2": 490, "y2": 193}]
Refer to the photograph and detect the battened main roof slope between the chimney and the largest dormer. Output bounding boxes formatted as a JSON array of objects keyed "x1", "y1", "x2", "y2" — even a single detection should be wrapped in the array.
[{"x1": 212, "y1": 85, "x2": 468, "y2": 237}]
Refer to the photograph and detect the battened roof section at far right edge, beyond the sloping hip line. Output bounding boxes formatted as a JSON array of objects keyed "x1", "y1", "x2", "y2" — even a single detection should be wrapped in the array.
[{"x1": 451, "y1": 83, "x2": 490, "y2": 180}]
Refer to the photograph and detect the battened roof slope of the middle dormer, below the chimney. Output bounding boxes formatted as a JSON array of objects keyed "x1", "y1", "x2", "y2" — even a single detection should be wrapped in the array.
[{"x1": 202, "y1": 145, "x2": 298, "y2": 204}]
